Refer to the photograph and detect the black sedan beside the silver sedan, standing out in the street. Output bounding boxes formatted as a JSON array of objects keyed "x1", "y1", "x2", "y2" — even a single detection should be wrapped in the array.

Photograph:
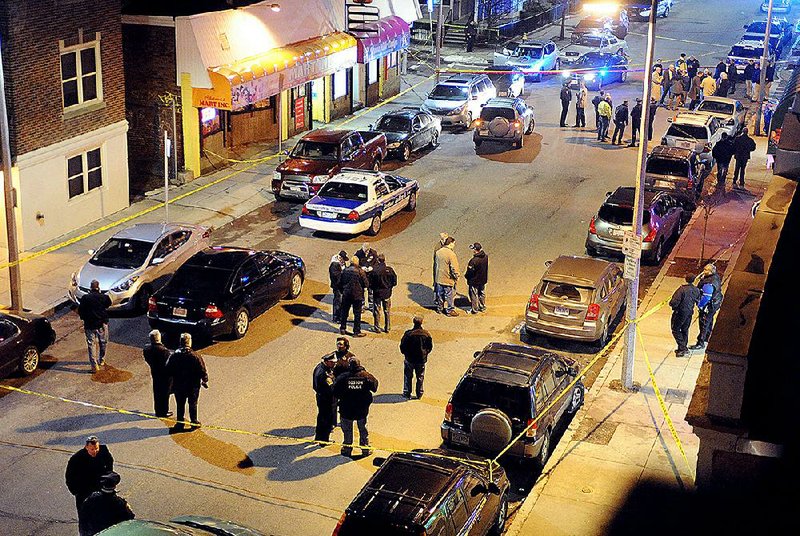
[{"x1": 147, "y1": 246, "x2": 306, "y2": 339}]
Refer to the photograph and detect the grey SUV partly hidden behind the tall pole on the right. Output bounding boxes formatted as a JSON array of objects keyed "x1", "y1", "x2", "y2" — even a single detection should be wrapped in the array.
[{"x1": 586, "y1": 186, "x2": 691, "y2": 264}]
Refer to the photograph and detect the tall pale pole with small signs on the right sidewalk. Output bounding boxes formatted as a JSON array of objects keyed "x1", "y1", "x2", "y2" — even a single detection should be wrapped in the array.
[{"x1": 583, "y1": 0, "x2": 658, "y2": 389}]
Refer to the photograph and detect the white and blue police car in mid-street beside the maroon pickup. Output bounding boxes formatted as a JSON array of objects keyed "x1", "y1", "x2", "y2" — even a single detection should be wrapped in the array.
[{"x1": 300, "y1": 169, "x2": 419, "y2": 236}]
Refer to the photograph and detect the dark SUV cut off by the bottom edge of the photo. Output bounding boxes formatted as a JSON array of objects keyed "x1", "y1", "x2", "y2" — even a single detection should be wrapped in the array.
[{"x1": 333, "y1": 450, "x2": 509, "y2": 536}]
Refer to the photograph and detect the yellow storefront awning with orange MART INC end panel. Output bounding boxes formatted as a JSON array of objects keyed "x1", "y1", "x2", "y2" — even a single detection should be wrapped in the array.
[{"x1": 192, "y1": 32, "x2": 357, "y2": 110}]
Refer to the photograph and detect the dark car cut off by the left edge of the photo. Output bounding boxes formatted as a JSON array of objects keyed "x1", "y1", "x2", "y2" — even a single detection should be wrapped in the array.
[{"x1": 0, "y1": 311, "x2": 56, "y2": 378}]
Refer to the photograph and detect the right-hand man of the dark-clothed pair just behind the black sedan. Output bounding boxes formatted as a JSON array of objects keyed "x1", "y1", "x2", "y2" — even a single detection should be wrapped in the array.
[{"x1": 167, "y1": 333, "x2": 208, "y2": 431}]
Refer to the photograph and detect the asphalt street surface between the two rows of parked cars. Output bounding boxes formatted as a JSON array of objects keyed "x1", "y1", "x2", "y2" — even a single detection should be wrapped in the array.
[{"x1": 0, "y1": 0, "x2": 772, "y2": 535}]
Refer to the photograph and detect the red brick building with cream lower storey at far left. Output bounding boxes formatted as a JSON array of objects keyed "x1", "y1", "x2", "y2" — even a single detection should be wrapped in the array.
[{"x1": 0, "y1": 0, "x2": 128, "y2": 249}]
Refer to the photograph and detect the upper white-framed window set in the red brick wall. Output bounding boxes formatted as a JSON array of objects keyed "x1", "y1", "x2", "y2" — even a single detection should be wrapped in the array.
[{"x1": 59, "y1": 34, "x2": 103, "y2": 110}]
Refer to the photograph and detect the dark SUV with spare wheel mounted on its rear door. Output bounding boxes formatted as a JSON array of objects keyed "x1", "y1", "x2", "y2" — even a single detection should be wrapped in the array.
[{"x1": 442, "y1": 342, "x2": 584, "y2": 466}]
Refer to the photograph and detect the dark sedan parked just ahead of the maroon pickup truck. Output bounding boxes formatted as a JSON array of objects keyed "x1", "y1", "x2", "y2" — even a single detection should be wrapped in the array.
[{"x1": 375, "y1": 108, "x2": 442, "y2": 160}]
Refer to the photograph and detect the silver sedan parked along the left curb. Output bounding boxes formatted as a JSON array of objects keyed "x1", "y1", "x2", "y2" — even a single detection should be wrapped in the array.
[{"x1": 69, "y1": 223, "x2": 211, "y2": 312}]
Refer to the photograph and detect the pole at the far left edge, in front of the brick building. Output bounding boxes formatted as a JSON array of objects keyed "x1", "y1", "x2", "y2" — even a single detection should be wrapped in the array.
[{"x1": 0, "y1": 38, "x2": 22, "y2": 311}]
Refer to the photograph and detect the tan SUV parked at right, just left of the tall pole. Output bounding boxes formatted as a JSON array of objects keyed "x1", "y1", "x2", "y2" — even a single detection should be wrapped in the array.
[{"x1": 525, "y1": 255, "x2": 627, "y2": 348}]
